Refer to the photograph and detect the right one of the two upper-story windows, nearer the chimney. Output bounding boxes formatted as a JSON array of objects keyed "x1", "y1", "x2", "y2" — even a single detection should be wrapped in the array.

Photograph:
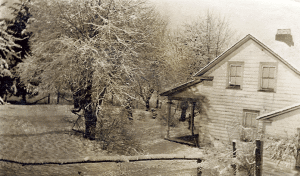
[{"x1": 259, "y1": 62, "x2": 277, "y2": 92}]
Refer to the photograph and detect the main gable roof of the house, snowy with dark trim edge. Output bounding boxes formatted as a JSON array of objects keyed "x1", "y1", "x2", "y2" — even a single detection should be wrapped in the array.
[{"x1": 194, "y1": 34, "x2": 300, "y2": 76}]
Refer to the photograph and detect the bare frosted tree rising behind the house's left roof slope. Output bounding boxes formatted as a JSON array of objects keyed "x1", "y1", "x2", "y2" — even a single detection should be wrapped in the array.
[{"x1": 182, "y1": 11, "x2": 236, "y2": 71}]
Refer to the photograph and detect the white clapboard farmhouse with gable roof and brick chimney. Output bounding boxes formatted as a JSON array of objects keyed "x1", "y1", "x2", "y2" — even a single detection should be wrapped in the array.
[{"x1": 160, "y1": 30, "x2": 300, "y2": 143}]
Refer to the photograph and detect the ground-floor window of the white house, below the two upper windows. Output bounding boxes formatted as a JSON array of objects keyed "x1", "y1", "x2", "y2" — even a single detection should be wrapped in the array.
[{"x1": 241, "y1": 110, "x2": 259, "y2": 142}]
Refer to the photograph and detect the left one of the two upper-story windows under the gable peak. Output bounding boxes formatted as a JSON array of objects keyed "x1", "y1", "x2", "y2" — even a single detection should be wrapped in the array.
[{"x1": 227, "y1": 62, "x2": 244, "y2": 89}]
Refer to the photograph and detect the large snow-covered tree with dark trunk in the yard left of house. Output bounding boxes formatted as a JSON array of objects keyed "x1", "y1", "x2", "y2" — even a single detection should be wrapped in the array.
[{"x1": 19, "y1": 0, "x2": 164, "y2": 139}]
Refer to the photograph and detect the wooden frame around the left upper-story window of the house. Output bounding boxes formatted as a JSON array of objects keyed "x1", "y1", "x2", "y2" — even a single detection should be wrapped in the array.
[{"x1": 226, "y1": 61, "x2": 244, "y2": 90}]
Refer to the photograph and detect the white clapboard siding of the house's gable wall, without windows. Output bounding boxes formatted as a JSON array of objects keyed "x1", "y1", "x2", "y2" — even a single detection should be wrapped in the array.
[{"x1": 188, "y1": 40, "x2": 300, "y2": 142}]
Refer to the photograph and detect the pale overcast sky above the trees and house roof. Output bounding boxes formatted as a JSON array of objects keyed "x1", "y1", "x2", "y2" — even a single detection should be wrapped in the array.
[{"x1": 0, "y1": 0, "x2": 300, "y2": 45}]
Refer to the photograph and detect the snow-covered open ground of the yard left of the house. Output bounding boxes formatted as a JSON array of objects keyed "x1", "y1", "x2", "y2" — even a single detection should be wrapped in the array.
[{"x1": 0, "y1": 105, "x2": 199, "y2": 176}]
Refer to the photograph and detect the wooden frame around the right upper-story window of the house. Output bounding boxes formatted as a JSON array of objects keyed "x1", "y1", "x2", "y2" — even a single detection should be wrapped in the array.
[{"x1": 258, "y1": 62, "x2": 278, "y2": 92}]
